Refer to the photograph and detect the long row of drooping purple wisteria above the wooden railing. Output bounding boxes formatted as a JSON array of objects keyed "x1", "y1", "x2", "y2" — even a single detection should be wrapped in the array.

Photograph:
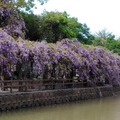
[{"x1": 0, "y1": 31, "x2": 120, "y2": 85}]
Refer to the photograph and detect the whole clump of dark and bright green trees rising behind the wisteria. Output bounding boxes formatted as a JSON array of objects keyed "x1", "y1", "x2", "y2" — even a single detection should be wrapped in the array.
[{"x1": 22, "y1": 11, "x2": 92, "y2": 43}]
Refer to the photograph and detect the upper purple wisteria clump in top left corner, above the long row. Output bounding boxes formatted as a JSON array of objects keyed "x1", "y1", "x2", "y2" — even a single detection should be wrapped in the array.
[{"x1": 0, "y1": 0, "x2": 26, "y2": 38}]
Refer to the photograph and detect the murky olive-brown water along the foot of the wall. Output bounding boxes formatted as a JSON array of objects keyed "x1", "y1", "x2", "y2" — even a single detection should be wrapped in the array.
[{"x1": 0, "y1": 97, "x2": 120, "y2": 120}]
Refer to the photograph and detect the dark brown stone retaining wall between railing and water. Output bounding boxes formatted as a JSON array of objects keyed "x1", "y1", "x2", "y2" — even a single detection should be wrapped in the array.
[{"x1": 0, "y1": 86, "x2": 120, "y2": 111}]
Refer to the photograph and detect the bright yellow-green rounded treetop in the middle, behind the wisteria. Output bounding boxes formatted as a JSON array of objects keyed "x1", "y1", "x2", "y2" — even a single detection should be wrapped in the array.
[{"x1": 40, "y1": 12, "x2": 80, "y2": 42}]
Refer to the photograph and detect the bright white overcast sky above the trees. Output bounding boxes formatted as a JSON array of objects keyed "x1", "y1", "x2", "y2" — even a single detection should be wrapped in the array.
[{"x1": 34, "y1": 0, "x2": 120, "y2": 37}]
